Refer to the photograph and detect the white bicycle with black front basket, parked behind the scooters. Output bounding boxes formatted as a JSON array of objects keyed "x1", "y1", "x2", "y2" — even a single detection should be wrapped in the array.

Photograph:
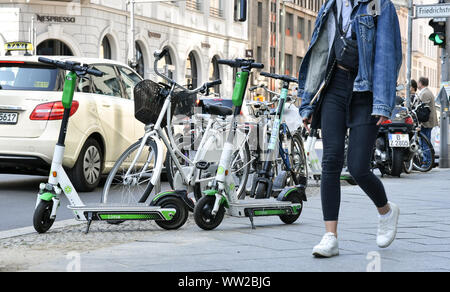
[{"x1": 101, "y1": 50, "x2": 251, "y2": 211}]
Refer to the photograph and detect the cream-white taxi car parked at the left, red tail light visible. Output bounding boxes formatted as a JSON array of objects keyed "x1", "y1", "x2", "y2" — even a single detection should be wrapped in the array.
[{"x1": 0, "y1": 56, "x2": 144, "y2": 191}]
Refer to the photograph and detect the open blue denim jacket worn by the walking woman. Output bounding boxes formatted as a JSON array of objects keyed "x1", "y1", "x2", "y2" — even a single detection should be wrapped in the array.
[{"x1": 298, "y1": 0, "x2": 402, "y2": 118}]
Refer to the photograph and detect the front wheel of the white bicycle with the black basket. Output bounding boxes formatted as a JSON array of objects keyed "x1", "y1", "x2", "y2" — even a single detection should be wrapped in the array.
[{"x1": 101, "y1": 139, "x2": 158, "y2": 205}]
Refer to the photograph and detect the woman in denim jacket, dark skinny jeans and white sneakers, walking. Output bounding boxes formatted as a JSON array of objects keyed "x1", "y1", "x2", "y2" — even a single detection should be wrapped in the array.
[{"x1": 298, "y1": 0, "x2": 402, "y2": 257}]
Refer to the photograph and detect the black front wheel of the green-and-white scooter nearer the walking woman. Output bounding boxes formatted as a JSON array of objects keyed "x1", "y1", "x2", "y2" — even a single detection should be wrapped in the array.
[{"x1": 194, "y1": 196, "x2": 225, "y2": 230}]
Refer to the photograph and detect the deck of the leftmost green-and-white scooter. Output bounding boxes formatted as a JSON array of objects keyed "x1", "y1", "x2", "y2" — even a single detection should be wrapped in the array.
[{"x1": 68, "y1": 204, "x2": 176, "y2": 221}]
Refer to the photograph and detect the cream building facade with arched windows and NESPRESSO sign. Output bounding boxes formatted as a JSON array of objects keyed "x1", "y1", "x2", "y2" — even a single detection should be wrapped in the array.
[{"x1": 0, "y1": 0, "x2": 248, "y2": 95}]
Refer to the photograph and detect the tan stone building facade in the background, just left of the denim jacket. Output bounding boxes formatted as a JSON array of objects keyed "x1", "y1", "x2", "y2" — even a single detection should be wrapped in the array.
[{"x1": 249, "y1": 0, "x2": 325, "y2": 92}]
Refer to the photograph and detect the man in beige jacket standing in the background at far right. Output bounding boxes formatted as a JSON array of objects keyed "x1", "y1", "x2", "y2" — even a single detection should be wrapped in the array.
[{"x1": 417, "y1": 77, "x2": 438, "y2": 167}]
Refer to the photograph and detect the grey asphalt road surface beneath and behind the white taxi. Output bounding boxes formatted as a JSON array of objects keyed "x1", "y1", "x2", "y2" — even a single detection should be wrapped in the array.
[{"x1": 0, "y1": 174, "x2": 174, "y2": 231}]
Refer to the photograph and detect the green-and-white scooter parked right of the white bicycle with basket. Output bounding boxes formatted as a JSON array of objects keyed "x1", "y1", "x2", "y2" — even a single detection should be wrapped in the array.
[{"x1": 194, "y1": 59, "x2": 306, "y2": 230}]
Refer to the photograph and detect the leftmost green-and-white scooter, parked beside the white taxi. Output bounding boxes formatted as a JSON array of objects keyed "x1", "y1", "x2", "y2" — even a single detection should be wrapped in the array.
[{"x1": 33, "y1": 57, "x2": 193, "y2": 233}]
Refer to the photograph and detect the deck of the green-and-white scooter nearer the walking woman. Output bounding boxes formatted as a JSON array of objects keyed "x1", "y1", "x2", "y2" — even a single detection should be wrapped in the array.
[{"x1": 228, "y1": 199, "x2": 302, "y2": 217}]
